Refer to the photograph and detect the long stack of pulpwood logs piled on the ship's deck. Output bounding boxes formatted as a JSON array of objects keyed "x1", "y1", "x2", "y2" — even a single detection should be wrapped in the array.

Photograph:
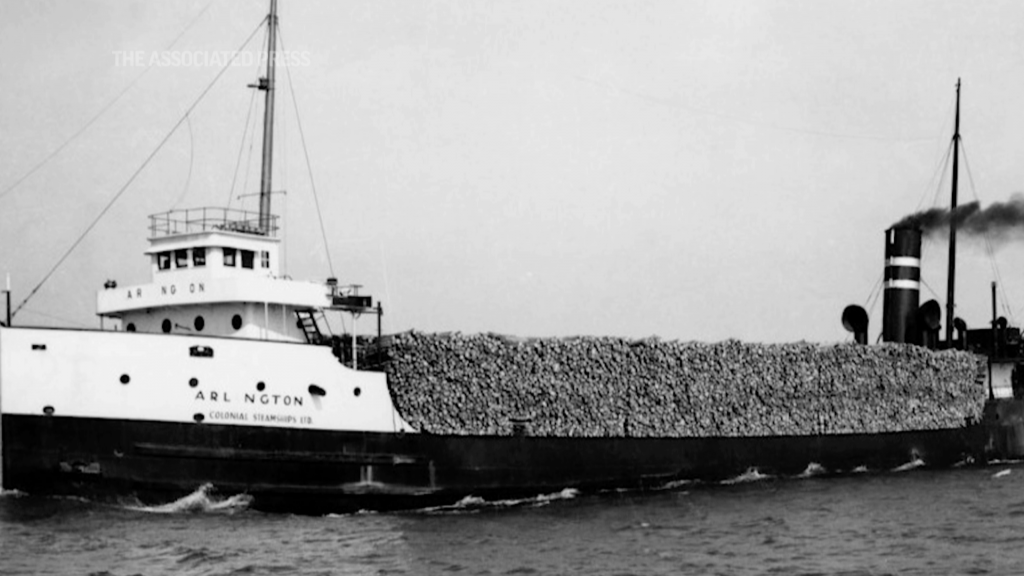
[{"x1": 372, "y1": 332, "x2": 987, "y2": 438}]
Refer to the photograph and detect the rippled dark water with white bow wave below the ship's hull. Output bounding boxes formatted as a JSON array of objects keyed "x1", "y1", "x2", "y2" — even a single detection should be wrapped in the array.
[{"x1": 0, "y1": 463, "x2": 1024, "y2": 576}]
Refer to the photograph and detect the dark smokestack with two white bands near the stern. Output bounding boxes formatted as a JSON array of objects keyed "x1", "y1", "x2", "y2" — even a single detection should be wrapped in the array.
[{"x1": 882, "y1": 228, "x2": 921, "y2": 343}]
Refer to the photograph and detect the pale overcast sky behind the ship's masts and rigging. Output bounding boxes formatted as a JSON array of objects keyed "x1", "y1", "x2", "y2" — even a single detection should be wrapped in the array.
[{"x1": 0, "y1": 0, "x2": 1024, "y2": 342}]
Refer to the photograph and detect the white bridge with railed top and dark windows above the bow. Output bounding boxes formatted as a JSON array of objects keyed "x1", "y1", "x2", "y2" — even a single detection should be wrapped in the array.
[{"x1": 96, "y1": 208, "x2": 338, "y2": 341}]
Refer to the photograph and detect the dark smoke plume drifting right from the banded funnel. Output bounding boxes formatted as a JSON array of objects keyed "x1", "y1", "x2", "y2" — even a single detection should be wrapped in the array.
[{"x1": 893, "y1": 194, "x2": 1024, "y2": 241}]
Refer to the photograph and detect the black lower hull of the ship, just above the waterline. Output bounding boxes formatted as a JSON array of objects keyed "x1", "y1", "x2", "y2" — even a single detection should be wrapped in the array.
[{"x1": 2, "y1": 415, "x2": 986, "y2": 513}]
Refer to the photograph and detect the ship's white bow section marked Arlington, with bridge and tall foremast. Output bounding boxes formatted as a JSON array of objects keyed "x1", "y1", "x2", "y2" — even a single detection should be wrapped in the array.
[{"x1": 0, "y1": 0, "x2": 407, "y2": 433}]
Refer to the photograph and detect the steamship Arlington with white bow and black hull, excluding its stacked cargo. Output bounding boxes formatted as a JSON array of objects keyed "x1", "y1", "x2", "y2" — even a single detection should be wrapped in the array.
[{"x1": 0, "y1": 0, "x2": 1024, "y2": 513}]
